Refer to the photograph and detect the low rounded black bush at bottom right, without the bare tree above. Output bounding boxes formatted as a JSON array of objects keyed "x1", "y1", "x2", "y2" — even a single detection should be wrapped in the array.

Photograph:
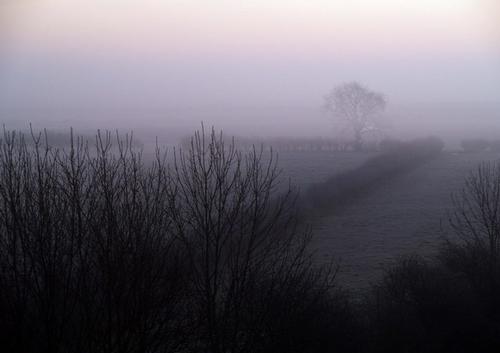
[{"x1": 367, "y1": 257, "x2": 500, "y2": 352}]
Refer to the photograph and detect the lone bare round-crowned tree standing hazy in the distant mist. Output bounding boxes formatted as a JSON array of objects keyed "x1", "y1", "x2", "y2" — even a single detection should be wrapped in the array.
[{"x1": 325, "y1": 82, "x2": 386, "y2": 151}]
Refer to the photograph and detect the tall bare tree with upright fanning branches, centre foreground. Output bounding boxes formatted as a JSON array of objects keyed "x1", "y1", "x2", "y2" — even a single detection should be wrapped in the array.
[{"x1": 166, "y1": 126, "x2": 342, "y2": 353}]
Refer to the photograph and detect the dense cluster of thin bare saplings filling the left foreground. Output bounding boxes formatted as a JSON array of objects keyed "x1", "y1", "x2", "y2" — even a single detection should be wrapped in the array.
[{"x1": 0, "y1": 132, "x2": 185, "y2": 353}]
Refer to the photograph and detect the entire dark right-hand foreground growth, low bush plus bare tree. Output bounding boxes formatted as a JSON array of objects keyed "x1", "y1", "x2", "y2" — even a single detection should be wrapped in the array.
[{"x1": 367, "y1": 164, "x2": 500, "y2": 352}]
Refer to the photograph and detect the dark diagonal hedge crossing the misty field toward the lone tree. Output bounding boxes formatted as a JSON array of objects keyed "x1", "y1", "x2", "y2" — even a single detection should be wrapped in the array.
[{"x1": 303, "y1": 137, "x2": 444, "y2": 209}]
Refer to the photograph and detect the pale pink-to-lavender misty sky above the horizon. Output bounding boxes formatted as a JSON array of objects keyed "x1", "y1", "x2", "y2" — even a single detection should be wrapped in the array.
[{"x1": 0, "y1": 0, "x2": 500, "y2": 132}]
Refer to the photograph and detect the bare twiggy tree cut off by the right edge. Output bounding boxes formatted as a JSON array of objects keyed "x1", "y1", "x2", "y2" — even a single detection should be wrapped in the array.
[{"x1": 441, "y1": 162, "x2": 500, "y2": 322}]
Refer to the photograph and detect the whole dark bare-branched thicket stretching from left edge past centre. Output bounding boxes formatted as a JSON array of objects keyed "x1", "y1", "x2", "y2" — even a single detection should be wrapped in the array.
[{"x1": 0, "y1": 132, "x2": 357, "y2": 353}]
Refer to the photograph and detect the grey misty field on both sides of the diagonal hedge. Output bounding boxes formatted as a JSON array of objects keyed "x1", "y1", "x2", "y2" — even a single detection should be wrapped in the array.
[{"x1": 279, "y1": 152, "x2": 499, "y2": 290}]
